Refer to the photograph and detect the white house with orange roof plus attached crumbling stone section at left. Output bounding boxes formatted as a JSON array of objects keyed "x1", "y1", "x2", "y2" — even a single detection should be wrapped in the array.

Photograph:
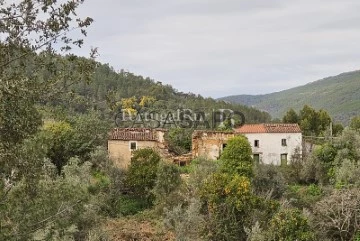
[{"x1": 192, "y1": 124, "x2": 302, "y2": 165}]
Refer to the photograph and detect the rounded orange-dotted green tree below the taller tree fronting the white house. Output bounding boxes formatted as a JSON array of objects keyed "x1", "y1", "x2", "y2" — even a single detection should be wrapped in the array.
[{"x1": 201, "y1": 172, "x2": 258, "y2": 240}]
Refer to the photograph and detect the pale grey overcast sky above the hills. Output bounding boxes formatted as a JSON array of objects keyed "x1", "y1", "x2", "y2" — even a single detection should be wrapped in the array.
[{"x1": 77, "y1": 0, "x2": 360, "y2": 98}]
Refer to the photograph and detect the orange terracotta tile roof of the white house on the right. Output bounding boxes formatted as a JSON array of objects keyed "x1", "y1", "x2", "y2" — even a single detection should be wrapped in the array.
[{"x1": 235, "y1": 123, "x2": 301, "y2": 134}]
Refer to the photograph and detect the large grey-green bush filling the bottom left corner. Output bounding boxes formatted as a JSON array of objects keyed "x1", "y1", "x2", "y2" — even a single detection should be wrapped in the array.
[{"x1": 0, "y1": 158, "x2": 101, "y2": 240}]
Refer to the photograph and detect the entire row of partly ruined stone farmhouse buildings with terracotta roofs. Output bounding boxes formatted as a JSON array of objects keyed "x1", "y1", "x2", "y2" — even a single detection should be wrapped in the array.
[{"x1": 108, "y1": 124, "x2": 302, "y2": 169}]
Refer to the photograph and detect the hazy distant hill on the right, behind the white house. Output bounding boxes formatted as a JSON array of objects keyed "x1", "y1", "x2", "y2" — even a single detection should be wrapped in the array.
[{"x1": 220, "y1": 71, "x2": 360, "y2": 123}]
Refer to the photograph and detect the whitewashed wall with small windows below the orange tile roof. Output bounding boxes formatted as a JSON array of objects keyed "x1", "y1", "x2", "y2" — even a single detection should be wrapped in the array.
[{"x1": 245, "y1": 133, "x2": 302, "y2": 165}]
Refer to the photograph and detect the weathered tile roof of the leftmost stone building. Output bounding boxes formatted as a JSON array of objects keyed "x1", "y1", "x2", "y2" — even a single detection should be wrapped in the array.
[{"x1": 110, "y1": 128, "x2": 157, "y2": 141}]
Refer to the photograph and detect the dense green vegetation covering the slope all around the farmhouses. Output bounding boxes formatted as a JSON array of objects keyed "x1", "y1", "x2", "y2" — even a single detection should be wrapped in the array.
[{"x1": 0, "y1": 0, "x2": 360, "y2": 241}]
